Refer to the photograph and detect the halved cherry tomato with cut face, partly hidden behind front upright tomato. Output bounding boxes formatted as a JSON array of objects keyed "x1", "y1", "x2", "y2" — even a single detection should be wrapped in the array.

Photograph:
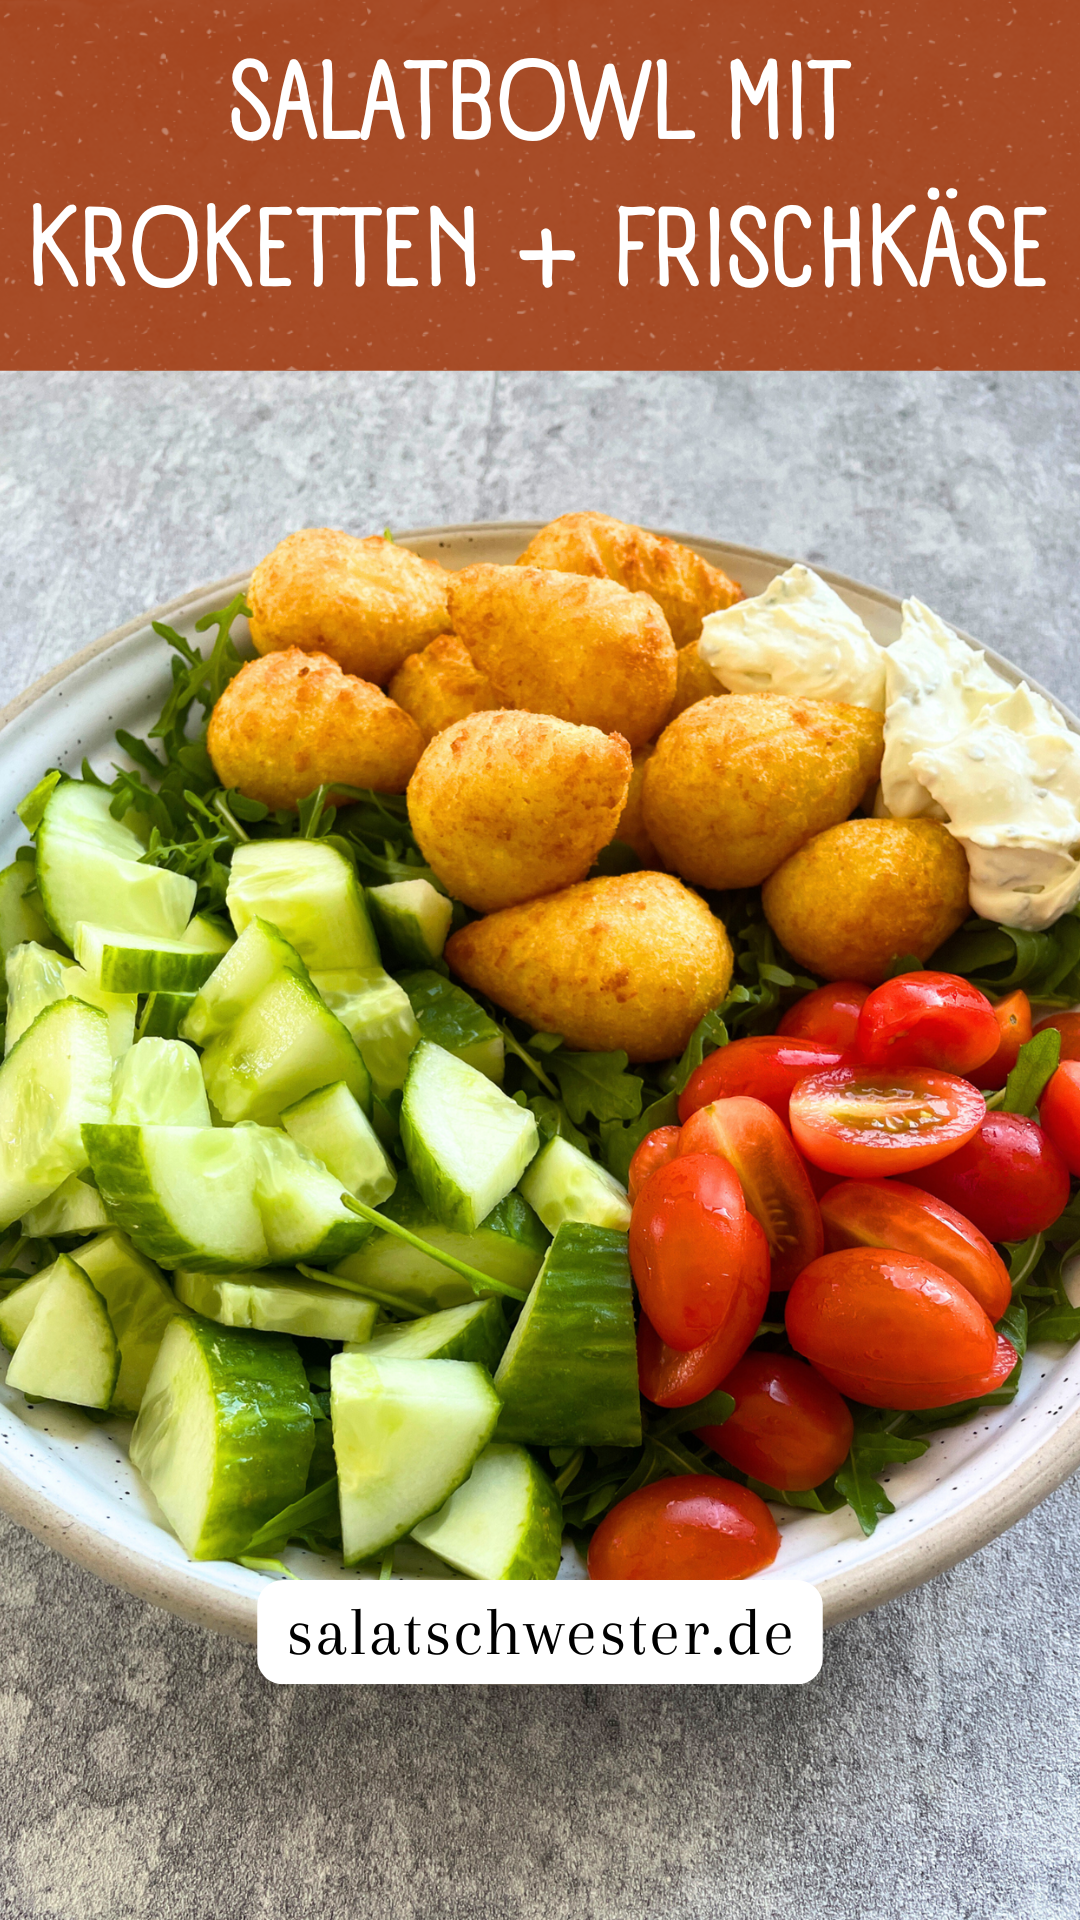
[{"x1": 678, "y1": 1096, "x2": 824, "y2": 1292}]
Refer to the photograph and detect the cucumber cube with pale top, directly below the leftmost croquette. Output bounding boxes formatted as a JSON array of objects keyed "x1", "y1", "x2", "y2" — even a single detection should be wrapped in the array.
[{"x1": 225, "y1": 839, "x2": 379, "y2": 970}]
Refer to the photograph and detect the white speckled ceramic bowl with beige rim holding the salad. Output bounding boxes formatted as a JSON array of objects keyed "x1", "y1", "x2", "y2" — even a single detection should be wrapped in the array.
[{"x1": 0, "y1": 524, "x2": 1080, "y2": 1640}]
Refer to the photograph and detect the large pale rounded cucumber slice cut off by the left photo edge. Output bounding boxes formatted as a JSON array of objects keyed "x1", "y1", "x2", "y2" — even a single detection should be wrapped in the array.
[{"x1": 0, "y1": 1000, "x2": 111, "y2": 1227}]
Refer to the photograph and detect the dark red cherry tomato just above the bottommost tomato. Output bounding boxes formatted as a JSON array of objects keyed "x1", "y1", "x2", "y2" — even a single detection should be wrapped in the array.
[{"x1": 698, "y1": 1354, "x2": 855, "y2": 1494}]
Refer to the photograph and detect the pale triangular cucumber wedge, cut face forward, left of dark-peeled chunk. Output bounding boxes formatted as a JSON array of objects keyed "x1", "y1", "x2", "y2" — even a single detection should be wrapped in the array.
[{"x1": 331, "y1": 1352, "x2": 500, "y2": 1567}]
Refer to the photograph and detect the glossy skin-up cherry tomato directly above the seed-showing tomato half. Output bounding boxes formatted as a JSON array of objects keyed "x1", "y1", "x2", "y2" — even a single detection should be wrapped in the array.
[{"x1": 855, "y1": 973, "x2": 1001, "y2": 1073}]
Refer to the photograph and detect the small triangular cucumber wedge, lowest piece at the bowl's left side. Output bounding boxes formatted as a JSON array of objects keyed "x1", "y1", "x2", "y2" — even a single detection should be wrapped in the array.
[{"x1": 8, "y1": 1254, "x2": 119, "y2": 1409}]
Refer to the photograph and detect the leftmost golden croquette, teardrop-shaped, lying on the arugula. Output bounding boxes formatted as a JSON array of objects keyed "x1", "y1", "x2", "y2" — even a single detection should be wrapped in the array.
[{"x1": 206, "y1": 647, "x2": 423, "y2": 806}]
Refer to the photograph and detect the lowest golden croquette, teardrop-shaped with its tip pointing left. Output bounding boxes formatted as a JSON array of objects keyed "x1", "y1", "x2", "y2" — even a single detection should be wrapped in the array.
[{"x1": 446, "y1": 874, "x2": 732, "y2": 1060}]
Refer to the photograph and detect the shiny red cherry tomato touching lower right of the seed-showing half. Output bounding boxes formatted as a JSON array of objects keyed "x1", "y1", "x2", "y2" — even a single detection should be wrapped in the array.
[{"x1": 911, "y1": 1114, "x2": 1068, "y2": 1240}]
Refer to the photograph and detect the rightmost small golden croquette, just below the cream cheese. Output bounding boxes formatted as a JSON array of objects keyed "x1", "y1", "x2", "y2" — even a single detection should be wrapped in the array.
[{"x1": 761, "y1": 820, "x2": 969, "y2": 987}]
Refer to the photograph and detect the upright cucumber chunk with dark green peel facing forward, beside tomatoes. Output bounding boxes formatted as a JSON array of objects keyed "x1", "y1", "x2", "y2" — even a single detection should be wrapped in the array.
[{"x1": 496, "y1": 1225, "x2": 642, "y2": 1446}]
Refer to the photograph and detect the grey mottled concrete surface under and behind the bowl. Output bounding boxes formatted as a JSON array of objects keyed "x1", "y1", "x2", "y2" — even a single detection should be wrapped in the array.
[{"x1": 0, "y1": 372, "x2": 1080, "y2": 1920}]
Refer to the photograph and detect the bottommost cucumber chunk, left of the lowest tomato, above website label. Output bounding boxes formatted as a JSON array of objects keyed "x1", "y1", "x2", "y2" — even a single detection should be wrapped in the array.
[{"x1": 413, "y1": 1440, "x2": 563, "y2": 1580}]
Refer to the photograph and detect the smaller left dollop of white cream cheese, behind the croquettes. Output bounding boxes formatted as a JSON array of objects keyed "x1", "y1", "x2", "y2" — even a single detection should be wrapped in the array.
[{"x1": 698, "y1": 566, "x2": 886, "y2": 712}]
